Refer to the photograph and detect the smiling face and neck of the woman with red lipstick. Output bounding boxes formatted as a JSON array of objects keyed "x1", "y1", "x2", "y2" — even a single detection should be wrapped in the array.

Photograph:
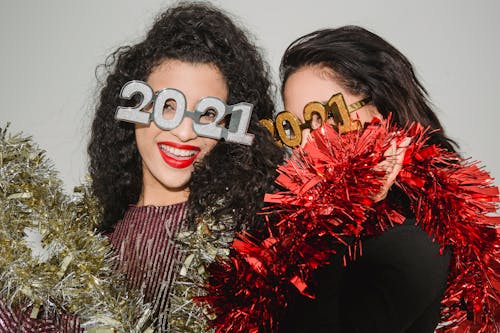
[{"x1": 135, "y1": 59, "x2": 228, "y2": 205}]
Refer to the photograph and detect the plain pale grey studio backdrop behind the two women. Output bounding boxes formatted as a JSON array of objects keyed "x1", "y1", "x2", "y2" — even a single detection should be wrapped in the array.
[{"x1": 0, "y1": 0, "x2": 500, "y2": 198}]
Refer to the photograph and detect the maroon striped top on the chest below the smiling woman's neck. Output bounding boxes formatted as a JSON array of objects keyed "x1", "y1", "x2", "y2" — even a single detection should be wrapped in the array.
[{"x1": 108, "y1": 202, "x2": 187, "y2": 327}]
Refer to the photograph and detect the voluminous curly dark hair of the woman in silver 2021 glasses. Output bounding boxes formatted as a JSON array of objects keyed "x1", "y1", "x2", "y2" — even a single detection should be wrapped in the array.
[{"x1": 88, "y1": 2, "x2": 282, "y2": 230}]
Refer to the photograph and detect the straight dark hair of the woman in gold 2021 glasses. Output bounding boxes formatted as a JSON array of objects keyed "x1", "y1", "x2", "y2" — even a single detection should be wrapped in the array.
[{"x1": 280, "y1": 26, "x2": 458, "y2": 151}]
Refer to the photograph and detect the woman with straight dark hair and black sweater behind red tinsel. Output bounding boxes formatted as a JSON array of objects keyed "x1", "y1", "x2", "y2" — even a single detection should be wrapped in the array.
[{"x1": 280, "y1": 26, "x2": 454, "y2": 333}]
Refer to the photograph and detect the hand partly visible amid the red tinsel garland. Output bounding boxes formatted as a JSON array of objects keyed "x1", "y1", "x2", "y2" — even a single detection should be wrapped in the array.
[{"x1": 372, "y1": 137, "x2": 411, "y2": 202}]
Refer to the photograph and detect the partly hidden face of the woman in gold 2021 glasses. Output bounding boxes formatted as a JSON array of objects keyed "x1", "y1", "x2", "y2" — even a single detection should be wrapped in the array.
[{"x1": 283, "y1": 66, "x2": 382, "y2": 146}]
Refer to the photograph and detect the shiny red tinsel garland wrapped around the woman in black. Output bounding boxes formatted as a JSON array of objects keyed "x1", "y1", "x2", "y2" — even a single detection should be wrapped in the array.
[{"x1": 199, "y1": 121, "x2": 500, "y2": 333}]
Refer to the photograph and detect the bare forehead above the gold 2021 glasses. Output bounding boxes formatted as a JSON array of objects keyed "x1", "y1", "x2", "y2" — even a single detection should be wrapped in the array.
[{"x1": 283, "y1": 66, "x2": 344, "y2": 117}]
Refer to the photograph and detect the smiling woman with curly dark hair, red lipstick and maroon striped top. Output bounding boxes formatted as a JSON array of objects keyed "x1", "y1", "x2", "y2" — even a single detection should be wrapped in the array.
[{"x1": 0, "y1": 2, "x2": 282, "y2": 332}]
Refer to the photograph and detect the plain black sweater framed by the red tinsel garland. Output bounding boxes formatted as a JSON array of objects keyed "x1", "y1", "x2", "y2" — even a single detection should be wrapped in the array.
[{"x1": 280, "y1": 219, "x2": 450, "y2": 333}]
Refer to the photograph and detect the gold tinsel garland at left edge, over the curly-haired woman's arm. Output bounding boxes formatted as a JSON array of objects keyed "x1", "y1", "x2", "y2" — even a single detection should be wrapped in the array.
[{"x1": 0, "y1": 125, "x2": 151, "y2": 333}]
